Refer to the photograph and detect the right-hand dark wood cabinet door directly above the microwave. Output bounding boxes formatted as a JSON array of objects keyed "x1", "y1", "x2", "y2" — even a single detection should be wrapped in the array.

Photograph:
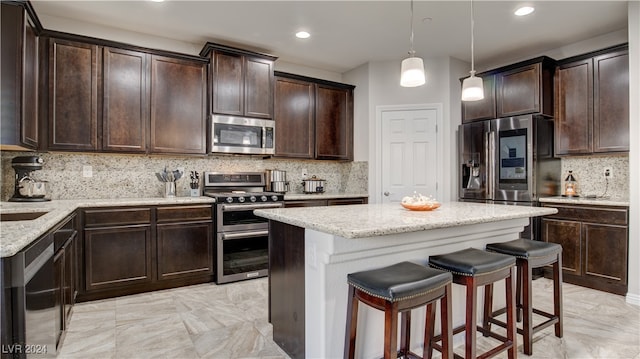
[{"x1": 244, "y1": 57, "x2": 273, "y2": 119}]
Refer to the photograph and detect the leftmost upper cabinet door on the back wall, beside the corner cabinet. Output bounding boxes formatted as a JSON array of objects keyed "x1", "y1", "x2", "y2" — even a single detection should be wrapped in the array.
[{"x1": 48, "y1": 39, "x2": 100, "y2": 151}]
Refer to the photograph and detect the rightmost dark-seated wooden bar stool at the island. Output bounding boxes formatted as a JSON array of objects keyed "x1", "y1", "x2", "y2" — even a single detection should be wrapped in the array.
[{"x1": 483, "y1": 239, "x2": 562, "y2": 355}]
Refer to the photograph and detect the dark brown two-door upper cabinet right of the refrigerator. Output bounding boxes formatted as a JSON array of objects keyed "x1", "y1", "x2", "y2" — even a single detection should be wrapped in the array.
[{"x1": 555, "y1": 45, "x2": 629, "y2": 155}]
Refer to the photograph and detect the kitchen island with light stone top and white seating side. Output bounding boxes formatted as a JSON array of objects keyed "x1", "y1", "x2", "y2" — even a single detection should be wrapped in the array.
[{"x1": 255, "y1": 202, "x2": 555, "y2": 358}]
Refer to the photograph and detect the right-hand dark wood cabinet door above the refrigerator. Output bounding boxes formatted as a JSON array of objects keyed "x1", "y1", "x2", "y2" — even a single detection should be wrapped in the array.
[{"x1": 496, "y1": 64, "x2": 541, "y2": 117}]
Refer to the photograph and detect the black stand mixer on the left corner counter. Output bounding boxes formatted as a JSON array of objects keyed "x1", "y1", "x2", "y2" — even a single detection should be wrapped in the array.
[{"x1": 9, "y1": 156, "x2": 51, "y2": 202}]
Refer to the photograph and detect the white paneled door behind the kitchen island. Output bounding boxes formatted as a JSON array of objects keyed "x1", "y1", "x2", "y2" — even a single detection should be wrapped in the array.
[{"x1": 380, "y1": 107, "x2": 442, "y2": 203}]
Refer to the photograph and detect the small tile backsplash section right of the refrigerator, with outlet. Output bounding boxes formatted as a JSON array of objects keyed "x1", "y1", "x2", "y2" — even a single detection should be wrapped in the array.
[{"x1": 562, "y1": 154, "x2": 629, "y2": 199}]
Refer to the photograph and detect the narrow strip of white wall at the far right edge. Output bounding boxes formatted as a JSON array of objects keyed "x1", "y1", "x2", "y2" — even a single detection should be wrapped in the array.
[{"x1": 627, "y1": 1, "x2": 640, "y2": 305}]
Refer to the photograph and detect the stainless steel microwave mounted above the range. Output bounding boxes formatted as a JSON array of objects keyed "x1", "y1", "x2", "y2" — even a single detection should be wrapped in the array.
[{"x1": 211, "y1": 115, "x2": 276, "y2": 155}]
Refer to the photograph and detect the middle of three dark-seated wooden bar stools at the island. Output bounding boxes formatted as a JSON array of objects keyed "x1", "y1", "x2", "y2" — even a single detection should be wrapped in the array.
[{"x1": 429, "y1": 248, "x2": 516, "y2": 359}]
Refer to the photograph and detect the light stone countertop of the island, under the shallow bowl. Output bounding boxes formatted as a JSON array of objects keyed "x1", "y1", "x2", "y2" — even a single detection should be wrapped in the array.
[{"x1": 254, "y1": 202, "x2": 557, "y2": 238}]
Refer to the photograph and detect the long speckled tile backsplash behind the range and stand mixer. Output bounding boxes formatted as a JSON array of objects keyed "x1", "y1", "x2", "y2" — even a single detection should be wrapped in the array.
[{"x1": 0, "y1": 151, "x2": 368, "y2": 201}]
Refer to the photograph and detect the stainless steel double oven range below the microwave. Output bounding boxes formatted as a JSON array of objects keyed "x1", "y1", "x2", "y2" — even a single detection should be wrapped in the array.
[{"x1": 204, "y1": 172, "x2": 284, "y2": 284}]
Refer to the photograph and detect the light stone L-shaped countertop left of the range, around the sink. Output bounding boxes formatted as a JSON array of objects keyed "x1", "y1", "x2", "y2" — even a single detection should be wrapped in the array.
[{"x1": 0, "y1": 197, "x2": 215, "y2": 258}]
